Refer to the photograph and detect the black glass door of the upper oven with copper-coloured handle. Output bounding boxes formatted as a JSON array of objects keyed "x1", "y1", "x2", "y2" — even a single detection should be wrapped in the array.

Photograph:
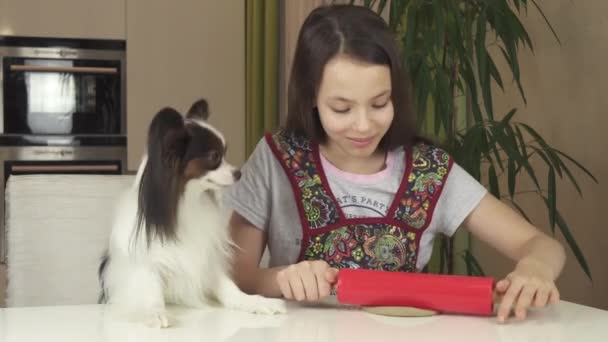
[{"x1": 2, "y1": 57, "x2": 122, "y2": 135}]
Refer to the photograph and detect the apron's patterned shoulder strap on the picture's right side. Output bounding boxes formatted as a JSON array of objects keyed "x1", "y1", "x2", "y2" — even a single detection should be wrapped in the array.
[{"x1": 394, "y1": 144, "x2": 450, "y2": 229}]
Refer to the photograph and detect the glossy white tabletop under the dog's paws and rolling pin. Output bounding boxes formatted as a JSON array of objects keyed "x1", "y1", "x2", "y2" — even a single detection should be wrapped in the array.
[{"x1": 0, "y1": 302, "x2": 608, "y2": 342}]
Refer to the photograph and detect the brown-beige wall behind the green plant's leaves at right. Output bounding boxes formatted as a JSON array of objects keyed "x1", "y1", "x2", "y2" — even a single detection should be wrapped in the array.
[{"x1": 477, "y1": 0, "x2": 608, "y2": 309}]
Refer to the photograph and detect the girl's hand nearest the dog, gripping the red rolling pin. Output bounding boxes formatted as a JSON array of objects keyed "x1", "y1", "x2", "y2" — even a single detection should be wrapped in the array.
[{"x1": 276, "y1": 260, "x2": 338, "y2": 301}]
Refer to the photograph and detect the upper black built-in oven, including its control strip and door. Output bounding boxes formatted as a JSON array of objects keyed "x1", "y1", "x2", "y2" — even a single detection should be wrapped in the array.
[{"x1": 0, "y1": 37, "x2": 126, "y2": 135}]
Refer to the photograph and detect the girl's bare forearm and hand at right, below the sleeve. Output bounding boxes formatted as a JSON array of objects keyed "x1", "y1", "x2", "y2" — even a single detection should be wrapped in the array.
[{"x1": 464, "y1": 194, "x2": 566, "y2": 321}]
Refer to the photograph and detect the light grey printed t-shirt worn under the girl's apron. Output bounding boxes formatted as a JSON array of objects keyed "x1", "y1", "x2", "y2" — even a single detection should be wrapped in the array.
[{"x1": 225, "y1": 139, "x2": 487, "y2": 270}]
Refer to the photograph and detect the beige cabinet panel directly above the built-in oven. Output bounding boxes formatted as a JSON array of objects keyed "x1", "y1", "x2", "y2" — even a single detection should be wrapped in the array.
[{"x1": 0, "y1": 0, "x2": 126, "y2": 39}]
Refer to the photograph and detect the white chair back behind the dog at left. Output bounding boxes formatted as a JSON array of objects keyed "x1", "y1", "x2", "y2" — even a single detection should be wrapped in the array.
[{"x1": 5, "y1": 174, "x2": 133, "y2": 307}]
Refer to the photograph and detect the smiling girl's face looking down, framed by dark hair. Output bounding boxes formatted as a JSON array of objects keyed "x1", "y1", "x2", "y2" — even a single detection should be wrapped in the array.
[{"x1": 317, "y1": 55, "x2": 394, "y2": 158}]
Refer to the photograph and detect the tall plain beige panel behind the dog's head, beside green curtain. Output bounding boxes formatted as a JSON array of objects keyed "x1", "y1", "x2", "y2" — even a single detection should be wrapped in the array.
[{"x1": 127, "y1": 0, "x2": 245, "y2": 170}]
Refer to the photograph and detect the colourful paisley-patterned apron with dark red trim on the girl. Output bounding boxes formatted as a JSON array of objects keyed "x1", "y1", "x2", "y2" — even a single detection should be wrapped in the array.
[{"x1": 266, "y1": 133, "x2": 452, "y2": 272}]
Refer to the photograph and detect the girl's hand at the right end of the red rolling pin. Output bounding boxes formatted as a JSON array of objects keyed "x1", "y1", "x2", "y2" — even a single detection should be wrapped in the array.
[{"x1": 496, "y1": 259, "x2": 559, "y2": 322}]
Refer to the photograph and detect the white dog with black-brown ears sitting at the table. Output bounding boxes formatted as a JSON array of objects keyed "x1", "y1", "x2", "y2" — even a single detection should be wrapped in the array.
[{"x1": 99, "y1": 99, "x2": 285, "y2": 327}]
